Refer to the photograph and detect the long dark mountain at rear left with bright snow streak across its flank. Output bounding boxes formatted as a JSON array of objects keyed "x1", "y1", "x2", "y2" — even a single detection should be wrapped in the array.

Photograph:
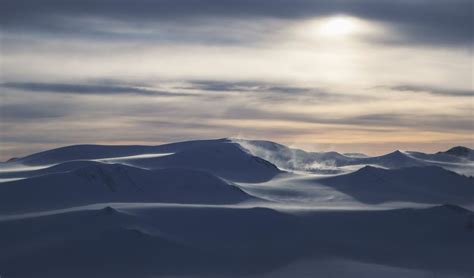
[{"x1": 0, "y1": 139, "x2": 281, "y2": 182}]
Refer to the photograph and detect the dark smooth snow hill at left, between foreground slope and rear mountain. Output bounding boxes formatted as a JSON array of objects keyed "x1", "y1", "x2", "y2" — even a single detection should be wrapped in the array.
[{"x1": 0, "y1": 161, "x2": 256, "y2": 213}]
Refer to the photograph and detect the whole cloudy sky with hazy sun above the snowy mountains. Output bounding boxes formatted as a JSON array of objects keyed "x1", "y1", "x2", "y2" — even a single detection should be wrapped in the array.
[{"x1": 0, "y1": 0, "x2": 474, "y2": 160}]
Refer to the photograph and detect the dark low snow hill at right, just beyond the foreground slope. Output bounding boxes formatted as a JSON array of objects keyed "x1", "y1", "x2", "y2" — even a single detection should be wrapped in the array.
[{"x1": 318, "y1": 166, "x2": 474, "y2": 204}]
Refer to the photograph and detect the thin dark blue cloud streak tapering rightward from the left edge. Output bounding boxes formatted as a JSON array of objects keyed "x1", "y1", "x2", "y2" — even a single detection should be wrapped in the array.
[{"x1": 0, "y1": 82, "x2": 191, "y2": 97}]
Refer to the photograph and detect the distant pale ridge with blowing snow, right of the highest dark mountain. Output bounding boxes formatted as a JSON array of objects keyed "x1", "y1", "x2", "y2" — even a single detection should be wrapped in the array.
[{"x1": 237, "y1": 139, "x2": 474, "y2": 176}]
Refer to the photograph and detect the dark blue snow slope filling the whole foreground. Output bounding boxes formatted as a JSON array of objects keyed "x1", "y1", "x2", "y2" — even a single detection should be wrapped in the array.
[{"x1": 0, "y1": 205, "x2": 474, "y2": 277}]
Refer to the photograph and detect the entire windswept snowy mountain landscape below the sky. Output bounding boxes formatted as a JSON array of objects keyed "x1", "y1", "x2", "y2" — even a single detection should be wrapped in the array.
[{"x1": 0, "y1": 139, "x2": 474, "y2": 277}]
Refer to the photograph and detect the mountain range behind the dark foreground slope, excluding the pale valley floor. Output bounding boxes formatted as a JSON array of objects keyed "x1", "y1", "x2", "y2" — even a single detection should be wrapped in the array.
[{"x1": 0, "y1": 139, "x2": 474, "y2": 212}]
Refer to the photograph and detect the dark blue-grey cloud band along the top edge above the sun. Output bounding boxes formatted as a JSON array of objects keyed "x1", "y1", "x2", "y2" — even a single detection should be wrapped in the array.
[{"x1": 0, "y1": 0, "x2": 473, "y2": 45}]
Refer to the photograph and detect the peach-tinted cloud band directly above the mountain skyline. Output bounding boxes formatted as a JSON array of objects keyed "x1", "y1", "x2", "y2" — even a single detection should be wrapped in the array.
[{"x1": 0, "y1": 86, "x2": 474, "y2": 159}]
